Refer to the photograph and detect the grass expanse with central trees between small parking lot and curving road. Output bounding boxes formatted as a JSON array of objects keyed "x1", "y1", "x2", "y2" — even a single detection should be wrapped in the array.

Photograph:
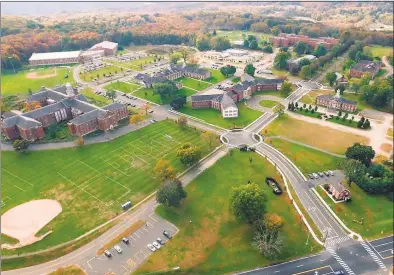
[{"x1": 137, "y1": 150, "x2": 320, "y2": 275}]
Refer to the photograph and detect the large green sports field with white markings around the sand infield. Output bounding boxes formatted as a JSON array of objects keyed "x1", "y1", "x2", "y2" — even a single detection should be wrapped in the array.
[{"x1": 1, "y1": 121, "x2": 214, "y2": 255}]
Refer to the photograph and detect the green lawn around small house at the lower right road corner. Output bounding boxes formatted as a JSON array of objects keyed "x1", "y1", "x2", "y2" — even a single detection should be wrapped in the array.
[{"x1": 316, "y1": 183, "x2": 393, "y2": 242}]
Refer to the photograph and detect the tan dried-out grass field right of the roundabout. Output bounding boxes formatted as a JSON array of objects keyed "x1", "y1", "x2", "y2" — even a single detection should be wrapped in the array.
[{"x1": 262, "y1": 115, "x2": 368, "y2": 154}]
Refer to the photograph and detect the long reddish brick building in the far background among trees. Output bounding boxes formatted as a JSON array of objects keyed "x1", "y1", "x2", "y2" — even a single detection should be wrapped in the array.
[{"x1": 270, "y1": 33, "x2": 339, "y2": 49}]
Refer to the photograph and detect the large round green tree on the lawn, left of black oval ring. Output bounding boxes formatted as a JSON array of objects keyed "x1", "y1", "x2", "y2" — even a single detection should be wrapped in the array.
[{"x1": 230, "y1": 183, "x2": 266, "y2": 224}]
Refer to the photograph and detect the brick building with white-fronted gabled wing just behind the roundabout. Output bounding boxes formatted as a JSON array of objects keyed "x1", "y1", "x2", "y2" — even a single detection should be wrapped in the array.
[{"x1": 191, "y1": 75, "x2": 283, "y2": 118}]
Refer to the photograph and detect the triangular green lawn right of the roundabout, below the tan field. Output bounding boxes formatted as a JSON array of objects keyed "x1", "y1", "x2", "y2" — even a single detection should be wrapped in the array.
[{"x1": 267, "y1": 139, "x2": 342, "y2": 175}]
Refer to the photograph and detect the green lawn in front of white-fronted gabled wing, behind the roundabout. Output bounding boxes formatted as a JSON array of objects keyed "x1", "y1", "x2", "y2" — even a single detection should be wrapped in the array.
[{"x1": 179, "y1": 102, "x2": 263, "y2": 129}]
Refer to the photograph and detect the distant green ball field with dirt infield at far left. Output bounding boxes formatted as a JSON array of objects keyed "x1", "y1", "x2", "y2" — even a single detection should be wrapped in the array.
[{"x1": 1, "y1": 67, "x2": 74, "y2": 96}]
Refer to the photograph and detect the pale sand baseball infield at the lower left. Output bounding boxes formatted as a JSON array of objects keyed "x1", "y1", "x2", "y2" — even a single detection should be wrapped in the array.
[{"x1": 1, "y1": 200, "x2": 62, "y2": 248}]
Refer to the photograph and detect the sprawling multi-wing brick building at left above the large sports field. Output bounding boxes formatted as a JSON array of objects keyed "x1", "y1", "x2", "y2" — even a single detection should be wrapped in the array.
[{"x1": 1, "y1": 84, "x2": 128, "y2": 141}]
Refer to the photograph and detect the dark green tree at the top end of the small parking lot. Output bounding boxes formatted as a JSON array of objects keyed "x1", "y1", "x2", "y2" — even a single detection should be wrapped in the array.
[{"x1": 156, "y1": 179, "x2": 187, "y2": 207}]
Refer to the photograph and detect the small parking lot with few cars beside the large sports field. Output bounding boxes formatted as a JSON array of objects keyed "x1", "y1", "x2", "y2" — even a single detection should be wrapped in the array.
[{"x1": 83, "y1": 213, "x2": 178, "y2": 275}]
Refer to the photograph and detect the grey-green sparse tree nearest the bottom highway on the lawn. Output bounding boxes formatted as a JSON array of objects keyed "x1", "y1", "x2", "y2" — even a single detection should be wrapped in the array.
[{"x1": 252, "y1": 223, "x2": 284, "y2": 259}]
